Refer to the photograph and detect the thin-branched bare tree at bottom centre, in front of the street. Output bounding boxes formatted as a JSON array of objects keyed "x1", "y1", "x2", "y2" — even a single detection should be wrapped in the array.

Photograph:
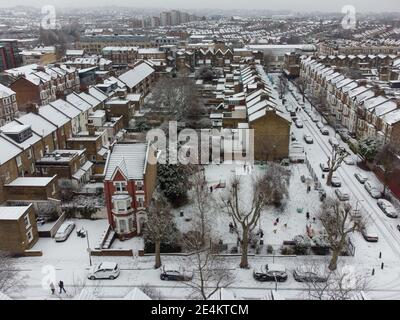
[{"x1": 183, "y1": 227, "x2": 233, "y2": 300}]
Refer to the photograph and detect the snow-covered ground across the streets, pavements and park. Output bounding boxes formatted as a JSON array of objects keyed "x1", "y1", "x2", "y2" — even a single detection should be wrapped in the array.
[{"x1": 3, "y1": 69, "x2": 400, "y2": 299}]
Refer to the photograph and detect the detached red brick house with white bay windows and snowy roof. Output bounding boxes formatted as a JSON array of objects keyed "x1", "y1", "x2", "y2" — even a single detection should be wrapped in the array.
[{"x1": 104, "y1": 143, "x2": 157, "y2": 239}]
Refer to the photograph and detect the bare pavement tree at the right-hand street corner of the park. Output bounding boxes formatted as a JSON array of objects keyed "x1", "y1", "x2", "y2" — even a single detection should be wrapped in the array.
[{"x1": 318, "y1": 198, "x2": 364, "y2": 271}]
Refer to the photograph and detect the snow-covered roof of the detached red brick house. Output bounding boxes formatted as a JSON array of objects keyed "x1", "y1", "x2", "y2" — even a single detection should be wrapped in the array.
[{"x1": 105, "y1": 143, "x2": 148, "y2": 180}]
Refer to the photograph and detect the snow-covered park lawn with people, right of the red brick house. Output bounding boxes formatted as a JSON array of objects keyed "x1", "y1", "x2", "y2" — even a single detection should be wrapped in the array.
[{"x1": 174, "y1": 164, "x2": 320, "y2": 249}]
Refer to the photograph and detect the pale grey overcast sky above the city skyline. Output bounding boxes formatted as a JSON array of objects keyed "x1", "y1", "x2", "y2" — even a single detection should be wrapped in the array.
[{"x1": 0, "y1": 0, "x2": 400, "y2": 12}]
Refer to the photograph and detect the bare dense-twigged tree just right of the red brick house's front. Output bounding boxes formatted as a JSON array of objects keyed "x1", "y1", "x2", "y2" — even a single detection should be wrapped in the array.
[{"x1": 144, "y1": 196, "x2": 176, "y2": 269}]
